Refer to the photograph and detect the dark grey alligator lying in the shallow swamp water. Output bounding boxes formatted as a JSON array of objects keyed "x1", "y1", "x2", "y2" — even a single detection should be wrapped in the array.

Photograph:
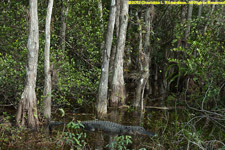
[{"x1": 49, "y1": 120, "x2": 155, "y2": 137}]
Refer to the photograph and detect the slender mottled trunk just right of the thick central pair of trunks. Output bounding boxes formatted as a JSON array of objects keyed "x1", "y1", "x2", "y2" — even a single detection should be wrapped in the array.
[{"x1": 134, "y1": 5, "x2": 154, "y2": 110}]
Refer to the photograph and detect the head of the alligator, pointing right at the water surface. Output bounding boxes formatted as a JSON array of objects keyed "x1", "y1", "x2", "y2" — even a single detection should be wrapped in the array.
[{"x1": 125, "y1": 126, "x2": 155, "y2": 137}]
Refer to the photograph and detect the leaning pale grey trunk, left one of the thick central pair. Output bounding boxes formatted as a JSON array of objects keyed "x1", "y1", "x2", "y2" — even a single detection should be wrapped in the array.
[{"x1": 97, "y1": 0, "x2": 116, "y2": 115}]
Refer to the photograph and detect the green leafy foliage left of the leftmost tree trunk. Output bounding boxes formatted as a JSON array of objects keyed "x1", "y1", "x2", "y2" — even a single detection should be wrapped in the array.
[{"x1": 0, "y1": 1, "x2": 27, "y2": 104}]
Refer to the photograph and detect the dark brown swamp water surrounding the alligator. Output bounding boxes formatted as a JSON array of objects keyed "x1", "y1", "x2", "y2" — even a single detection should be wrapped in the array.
[{"x1": 0, "y1": 106, "x2": 185, "y2": 150}]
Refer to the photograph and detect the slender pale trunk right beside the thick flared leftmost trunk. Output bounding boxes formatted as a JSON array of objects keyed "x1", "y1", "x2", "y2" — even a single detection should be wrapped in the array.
[{"x1": 43, "y1": 0, "x2": 53, "y2": 125}]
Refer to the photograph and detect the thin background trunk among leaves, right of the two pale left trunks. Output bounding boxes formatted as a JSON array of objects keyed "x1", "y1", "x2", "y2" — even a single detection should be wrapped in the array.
[{"x1": 60, "y1": 0, "x2": 69, "y2": 52}]
